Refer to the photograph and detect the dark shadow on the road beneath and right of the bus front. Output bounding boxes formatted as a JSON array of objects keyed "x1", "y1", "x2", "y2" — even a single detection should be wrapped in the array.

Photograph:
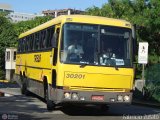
[{"x1": 60, "y1": 105, "x2": 160, "y2": 116}]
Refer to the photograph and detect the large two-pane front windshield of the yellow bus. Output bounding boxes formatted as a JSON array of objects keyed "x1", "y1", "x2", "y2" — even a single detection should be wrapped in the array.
[{"x1": 60, "y1": 23, "x2": 132, "y2": 67}]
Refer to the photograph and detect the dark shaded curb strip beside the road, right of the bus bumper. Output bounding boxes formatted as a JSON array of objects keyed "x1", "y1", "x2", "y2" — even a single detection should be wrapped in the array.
[{"x1": 132, "y1": 100, "x2": 160, "y2": 108}]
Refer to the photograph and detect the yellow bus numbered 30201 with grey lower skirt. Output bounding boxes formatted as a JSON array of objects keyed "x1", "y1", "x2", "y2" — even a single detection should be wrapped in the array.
[{"x1": 15, "y1": 15, "x2": 135, "y2": 110}]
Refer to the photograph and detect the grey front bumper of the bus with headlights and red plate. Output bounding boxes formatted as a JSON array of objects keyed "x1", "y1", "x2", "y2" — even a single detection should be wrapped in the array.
[{"x1": 54, "y1": 89, "x2": 132, "y2": 104}]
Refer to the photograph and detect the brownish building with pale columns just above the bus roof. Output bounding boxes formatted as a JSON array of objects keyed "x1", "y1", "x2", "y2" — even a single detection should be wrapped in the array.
[{"x1": 42, "y1": 9, "x2": 84, "y2": 17}]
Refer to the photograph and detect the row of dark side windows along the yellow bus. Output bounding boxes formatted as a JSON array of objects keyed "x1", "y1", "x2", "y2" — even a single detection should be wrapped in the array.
[{"x1": 17, "y1": 25, "x2": 58, "y2": 54}]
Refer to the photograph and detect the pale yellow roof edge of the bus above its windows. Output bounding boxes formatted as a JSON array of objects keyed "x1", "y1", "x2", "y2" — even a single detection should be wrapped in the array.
[{"x1": 19, "y1": 15, "x2": 131, "y2": 38}]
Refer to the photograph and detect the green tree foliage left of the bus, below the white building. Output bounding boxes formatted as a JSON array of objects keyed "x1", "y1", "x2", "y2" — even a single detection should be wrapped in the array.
[{"x1": 0, "y1": 13, "x2": 51, "y2": 79}]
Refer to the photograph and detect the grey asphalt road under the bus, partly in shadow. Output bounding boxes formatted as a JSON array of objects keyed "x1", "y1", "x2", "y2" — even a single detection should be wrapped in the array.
[{"x1": 0, "y1": 87, "x2": 160, "y2": 120}]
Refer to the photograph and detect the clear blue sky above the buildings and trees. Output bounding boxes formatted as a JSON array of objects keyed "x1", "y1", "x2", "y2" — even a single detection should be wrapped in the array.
[{"x1": 0, "y1": 0, "x2": 108, "y2": 13}]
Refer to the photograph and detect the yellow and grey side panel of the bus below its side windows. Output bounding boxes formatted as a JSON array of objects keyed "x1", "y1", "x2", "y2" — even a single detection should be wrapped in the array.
[{"x1": 16, "y1": 51, "x2": 52, "y2": 97}]
